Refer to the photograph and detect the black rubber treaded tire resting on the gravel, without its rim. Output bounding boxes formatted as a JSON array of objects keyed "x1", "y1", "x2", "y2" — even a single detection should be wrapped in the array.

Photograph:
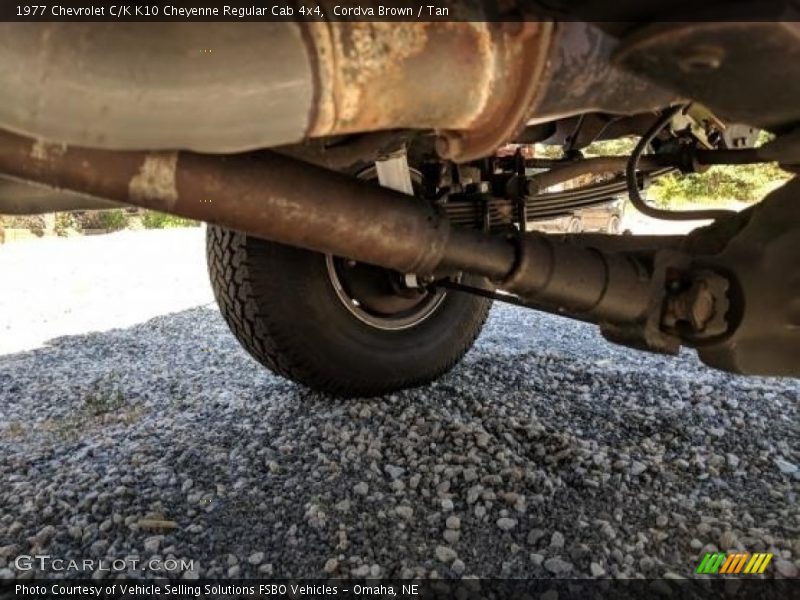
[{"x1": 206, "y1": 225, "x2": 491, "y2": 397}]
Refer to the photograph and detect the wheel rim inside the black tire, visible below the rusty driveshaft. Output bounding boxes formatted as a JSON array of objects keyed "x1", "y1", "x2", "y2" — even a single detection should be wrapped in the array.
[{"x1": 325, "y1": 254, "x2": 446, "y2": 330}]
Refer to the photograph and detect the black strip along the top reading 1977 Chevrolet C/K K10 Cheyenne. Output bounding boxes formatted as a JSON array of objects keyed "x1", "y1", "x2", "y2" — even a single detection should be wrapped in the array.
[{"x1": 0, "y1": 0, "x2": 800, "y2": 23}]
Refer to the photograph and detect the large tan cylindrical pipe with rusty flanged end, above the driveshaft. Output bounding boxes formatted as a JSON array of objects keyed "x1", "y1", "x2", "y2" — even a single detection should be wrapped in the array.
[{"x1": 0, "y1": 19, "x2": 554, "y2": 160}]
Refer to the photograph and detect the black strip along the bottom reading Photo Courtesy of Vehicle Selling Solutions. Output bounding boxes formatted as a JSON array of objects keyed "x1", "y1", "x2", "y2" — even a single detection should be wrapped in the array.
[{"x1": 0, "y1": 576, "x2": 800, "y2": 600}]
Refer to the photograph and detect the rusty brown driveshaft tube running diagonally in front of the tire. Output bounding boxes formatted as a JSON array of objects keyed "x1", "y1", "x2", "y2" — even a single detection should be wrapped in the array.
[{"x1": 0, "y1": 131, "x2": 514, "y2": 278}]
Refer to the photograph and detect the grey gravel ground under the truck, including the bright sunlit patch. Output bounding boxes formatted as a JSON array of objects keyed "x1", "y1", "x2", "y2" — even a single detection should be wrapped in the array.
[{"x1": 0, "y1": 231, "x2": 800, "y2": 578}]
